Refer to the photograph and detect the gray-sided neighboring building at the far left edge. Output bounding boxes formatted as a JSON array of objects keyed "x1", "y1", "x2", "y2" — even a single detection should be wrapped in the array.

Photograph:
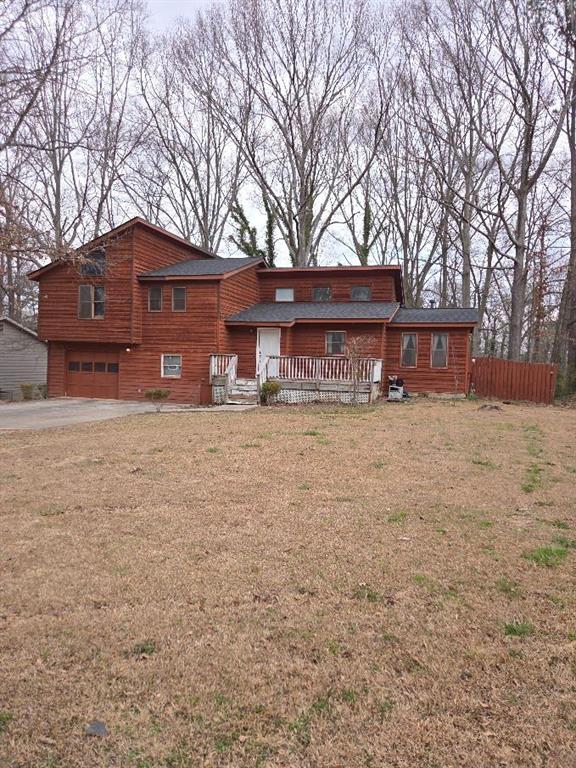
[{"x1": 0, "y1": 317, "x2": 48, "y2": 400}]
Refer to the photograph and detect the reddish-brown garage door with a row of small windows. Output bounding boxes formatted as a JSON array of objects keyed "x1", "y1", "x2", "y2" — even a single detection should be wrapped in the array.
[{"x1": 66, "y1": 351, "x2": 119, "y2": 399}]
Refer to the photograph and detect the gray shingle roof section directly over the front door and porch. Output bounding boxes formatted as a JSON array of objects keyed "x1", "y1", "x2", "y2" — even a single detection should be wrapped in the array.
[{"x1": 226, "y1": 301, "x2": 398, "y2": 323}]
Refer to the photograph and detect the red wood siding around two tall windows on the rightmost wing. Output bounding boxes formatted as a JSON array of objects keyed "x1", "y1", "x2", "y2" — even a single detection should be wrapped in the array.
[{"x1": 384, "y1": 326, "x2": 471, "y2": 394}]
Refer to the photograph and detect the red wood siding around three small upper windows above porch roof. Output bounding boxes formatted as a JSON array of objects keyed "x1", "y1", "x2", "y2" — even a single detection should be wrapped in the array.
[{"x1": 260, "y1": 271, "x2": 398, "y2": 302}]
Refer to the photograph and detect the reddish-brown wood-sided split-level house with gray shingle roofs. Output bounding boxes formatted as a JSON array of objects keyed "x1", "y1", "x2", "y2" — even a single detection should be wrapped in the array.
[{"x1": 30, "y1": 218, "x2": 475, "y2": 403}]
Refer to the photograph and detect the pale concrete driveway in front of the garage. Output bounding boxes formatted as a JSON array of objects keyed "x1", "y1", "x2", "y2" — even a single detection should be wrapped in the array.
[{"x1": 0, "y1": 397, "x2": 160, "y2": 431}]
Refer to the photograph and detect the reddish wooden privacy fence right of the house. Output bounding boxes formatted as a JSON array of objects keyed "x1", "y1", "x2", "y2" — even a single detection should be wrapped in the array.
[{"x1": 471, "y1": 357, "x2": 558, "y2": 403}]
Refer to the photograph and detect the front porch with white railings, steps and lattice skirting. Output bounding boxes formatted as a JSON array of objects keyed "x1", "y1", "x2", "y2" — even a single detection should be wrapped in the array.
[{"x1": 210, "y1": 354, "x2": 382, "y2": 404}]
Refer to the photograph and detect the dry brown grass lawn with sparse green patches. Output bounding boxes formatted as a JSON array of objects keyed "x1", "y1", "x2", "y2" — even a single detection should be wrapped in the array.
[{"x1": 0, "y1": 401, "x2": 576, "y2": 768}]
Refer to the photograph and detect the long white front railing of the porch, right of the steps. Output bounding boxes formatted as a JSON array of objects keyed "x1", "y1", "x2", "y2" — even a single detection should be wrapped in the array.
[{"x1": 259, "y1": 355, "x2": 382, "y2": 384}]
